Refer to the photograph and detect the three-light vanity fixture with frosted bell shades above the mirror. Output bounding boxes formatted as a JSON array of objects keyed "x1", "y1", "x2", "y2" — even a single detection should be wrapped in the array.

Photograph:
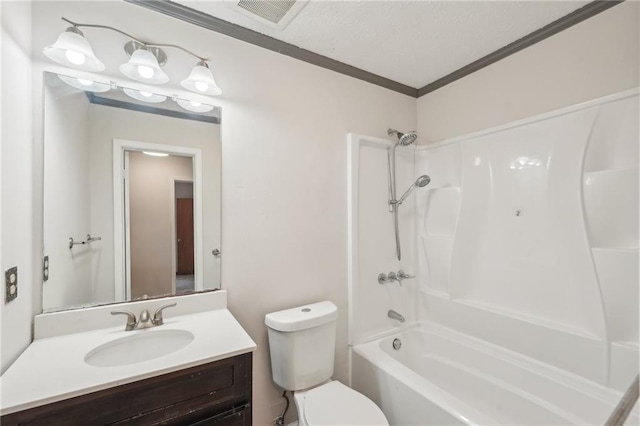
[{"x1": 43, "y1": 18, "x2": 222, "y2": 96}]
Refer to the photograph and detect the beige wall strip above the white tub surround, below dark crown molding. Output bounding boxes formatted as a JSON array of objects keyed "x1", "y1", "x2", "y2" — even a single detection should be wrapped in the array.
[{"x1": 418, "y1": 1, "x2": 640, "y2": 143}]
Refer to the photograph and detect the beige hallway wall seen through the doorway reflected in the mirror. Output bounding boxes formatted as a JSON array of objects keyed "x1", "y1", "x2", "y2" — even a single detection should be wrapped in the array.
[{"x1": 129, "y1": 152, "x2": 193, "y2": 298}]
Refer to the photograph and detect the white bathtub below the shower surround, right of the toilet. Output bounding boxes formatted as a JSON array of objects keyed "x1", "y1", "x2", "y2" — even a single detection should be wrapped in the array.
[{"x1": 351, "y1": 323, "x2": 638, "y2": 426}]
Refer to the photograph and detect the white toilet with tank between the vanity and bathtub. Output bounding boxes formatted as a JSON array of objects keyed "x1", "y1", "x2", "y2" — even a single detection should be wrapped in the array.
[{"x1": 265, "y1": 302, "x2": 389, "y2": 426}]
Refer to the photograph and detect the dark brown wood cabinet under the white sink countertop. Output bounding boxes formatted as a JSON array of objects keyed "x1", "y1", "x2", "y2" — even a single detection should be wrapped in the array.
[{"x1": 0, "y1": 353, "x2": 252, "y2": 426}]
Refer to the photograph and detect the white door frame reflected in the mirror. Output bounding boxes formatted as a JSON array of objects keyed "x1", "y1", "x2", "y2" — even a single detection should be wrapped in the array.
[{"x1": 113, "y1": 139, "x2": 204, "y2": 302}]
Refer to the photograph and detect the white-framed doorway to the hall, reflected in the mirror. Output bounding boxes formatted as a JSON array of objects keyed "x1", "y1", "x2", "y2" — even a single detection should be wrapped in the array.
[{"x1": 113, "y1": 139, "x2": 203, "y2": 300}]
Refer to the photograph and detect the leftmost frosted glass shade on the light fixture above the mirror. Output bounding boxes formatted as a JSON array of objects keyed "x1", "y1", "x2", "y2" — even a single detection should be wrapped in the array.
[{"x1": 42, "y1": 27, "x2": 104, "y2": 71}]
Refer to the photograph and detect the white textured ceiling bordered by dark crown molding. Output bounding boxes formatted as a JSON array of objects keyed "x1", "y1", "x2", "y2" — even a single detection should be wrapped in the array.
[{"x1": 176, "y1": 0, "x2": 589, "y2": 88}]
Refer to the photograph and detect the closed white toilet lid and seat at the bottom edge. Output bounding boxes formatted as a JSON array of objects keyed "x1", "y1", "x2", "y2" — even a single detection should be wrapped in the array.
[{"x1": 303, "y1": 381, "x2": 389, "y2": 426}]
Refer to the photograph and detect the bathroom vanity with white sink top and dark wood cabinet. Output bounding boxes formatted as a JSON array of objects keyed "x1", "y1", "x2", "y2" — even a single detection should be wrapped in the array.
[{"x1": 0, "y1": 291, "x2": 256, "y2": 426}]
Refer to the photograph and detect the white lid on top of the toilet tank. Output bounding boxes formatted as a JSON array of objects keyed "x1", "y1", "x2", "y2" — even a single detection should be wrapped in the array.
[{"x1": 264, "y1": 301, "x2": 338, "y2": 332}]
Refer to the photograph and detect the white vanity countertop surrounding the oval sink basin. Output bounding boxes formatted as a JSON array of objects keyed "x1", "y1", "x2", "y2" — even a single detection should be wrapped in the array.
[{"x1": 0, "y1": 309, "x2": 256, "y2": 415}]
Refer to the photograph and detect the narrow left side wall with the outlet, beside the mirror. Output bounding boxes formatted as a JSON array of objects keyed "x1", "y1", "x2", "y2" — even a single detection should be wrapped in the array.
[{"x1": 0, "y1": 1, "x2": 35, "y2": 372}]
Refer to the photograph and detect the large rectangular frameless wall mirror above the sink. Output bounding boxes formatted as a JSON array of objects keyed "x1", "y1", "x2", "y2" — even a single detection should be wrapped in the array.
[{"x1": 43, "y1": 73, "x2": 221, "y2": 312}]
